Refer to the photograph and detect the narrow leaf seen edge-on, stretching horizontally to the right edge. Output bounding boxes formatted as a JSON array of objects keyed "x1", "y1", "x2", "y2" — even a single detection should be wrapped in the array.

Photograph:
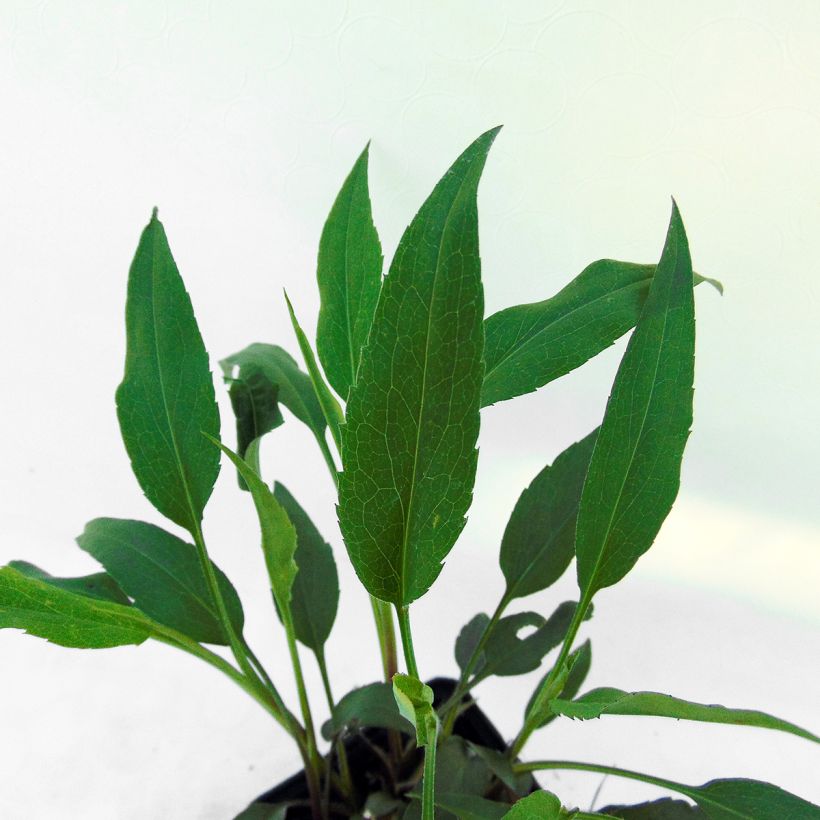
[{"x1": 550, "y1": 688, "x2": 820, "y2": 743}]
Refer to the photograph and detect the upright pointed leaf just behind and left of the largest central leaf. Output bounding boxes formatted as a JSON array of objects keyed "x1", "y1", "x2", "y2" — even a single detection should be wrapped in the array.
[{"x1": 316, "y1": 144, "x2": 382, "y2": 399}]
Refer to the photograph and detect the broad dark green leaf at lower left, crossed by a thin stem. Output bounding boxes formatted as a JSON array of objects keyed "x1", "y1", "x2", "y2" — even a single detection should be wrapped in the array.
[{"x1": 77, "y1": 518, "x2": 245, "y2": 645}]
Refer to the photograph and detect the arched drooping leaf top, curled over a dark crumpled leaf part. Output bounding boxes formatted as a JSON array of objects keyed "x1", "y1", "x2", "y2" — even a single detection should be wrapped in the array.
[{"x1": 224, "y1": 343, "x2": 327, "y2": 448}]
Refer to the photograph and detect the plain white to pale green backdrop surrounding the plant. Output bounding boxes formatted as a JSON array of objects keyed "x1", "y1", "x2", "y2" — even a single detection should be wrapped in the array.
[{"x1": 0, "y1": 0, "x2": 820, "y2": 820}]
